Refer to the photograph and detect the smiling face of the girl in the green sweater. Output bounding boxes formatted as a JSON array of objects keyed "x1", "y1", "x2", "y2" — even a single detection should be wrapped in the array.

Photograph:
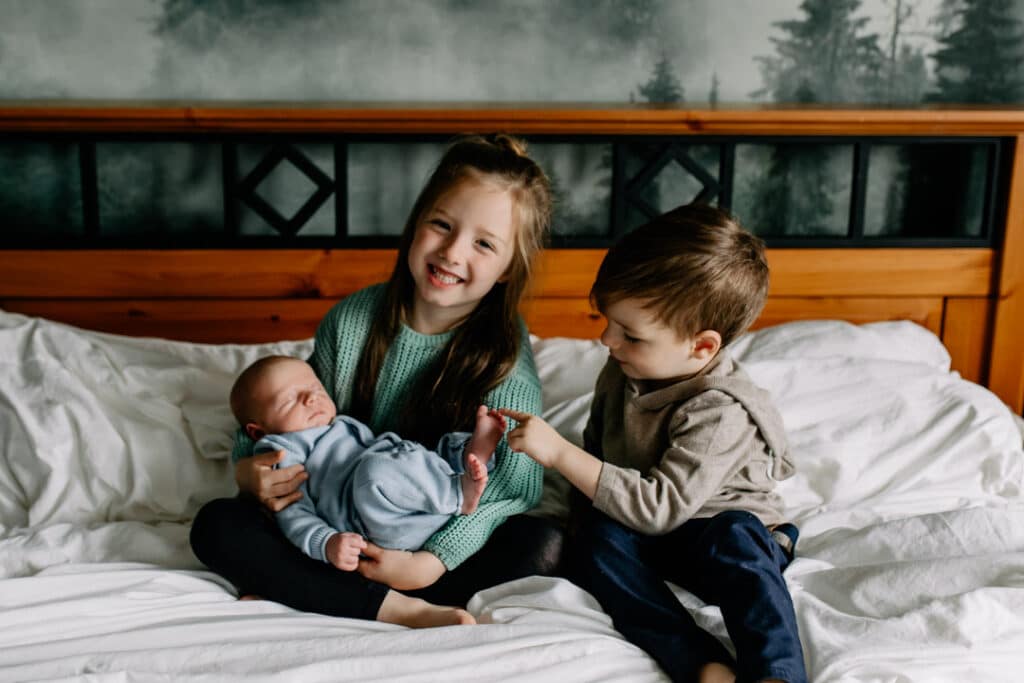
[{"x1": 409, "y1": 179, "x2": 516, "y2": 334}]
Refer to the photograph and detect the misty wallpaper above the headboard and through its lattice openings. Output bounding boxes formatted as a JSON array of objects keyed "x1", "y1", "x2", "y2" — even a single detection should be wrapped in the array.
[{"x1": 0, "y1": 0, "x2": 1024, "y2": 240}]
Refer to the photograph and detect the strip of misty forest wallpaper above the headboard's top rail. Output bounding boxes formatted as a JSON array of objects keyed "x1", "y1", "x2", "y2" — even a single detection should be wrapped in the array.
[{"x1": 0, "y1": 0, "x2": 1024, "y2": 105}]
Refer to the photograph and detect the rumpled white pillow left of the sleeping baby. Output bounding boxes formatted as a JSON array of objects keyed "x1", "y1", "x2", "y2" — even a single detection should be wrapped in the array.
[{"x1": 0, "y1": 311, "x2": 311, "y2": 531}]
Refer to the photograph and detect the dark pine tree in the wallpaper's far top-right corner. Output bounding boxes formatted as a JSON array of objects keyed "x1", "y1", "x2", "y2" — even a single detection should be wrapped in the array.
[{"x1": 928, "y1": 0, "x2": 1024, "y2": 104}]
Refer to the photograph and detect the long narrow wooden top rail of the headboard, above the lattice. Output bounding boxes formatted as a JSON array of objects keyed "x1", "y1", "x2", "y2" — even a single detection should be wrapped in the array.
[{"x1": 6, "y1": 100, "x2": 1024, "y2": 136}]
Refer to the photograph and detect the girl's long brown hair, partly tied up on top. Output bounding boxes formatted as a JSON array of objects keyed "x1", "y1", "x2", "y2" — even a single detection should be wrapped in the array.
[{"x1": 352, "y1": 135, "x2": 551, "y2": 443}]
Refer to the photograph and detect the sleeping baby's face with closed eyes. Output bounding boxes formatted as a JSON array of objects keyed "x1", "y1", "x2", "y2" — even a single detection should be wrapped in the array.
[{"x1": 253, "y1": 358, "x2": 338, "y2": 434}]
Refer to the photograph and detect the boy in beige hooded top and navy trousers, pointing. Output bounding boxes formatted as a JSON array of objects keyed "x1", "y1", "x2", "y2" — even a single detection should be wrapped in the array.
[{"x1": 503, "y1": 205, "x2": 807, "y2": 683}]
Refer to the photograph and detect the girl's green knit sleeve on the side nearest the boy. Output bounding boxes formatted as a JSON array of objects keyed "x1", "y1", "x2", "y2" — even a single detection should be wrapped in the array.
[{"x1": 423, "y1": 333, "x2": 544, "y2": 569}]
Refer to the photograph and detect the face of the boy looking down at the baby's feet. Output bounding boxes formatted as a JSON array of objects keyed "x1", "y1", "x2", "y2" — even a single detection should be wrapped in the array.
[{"x1": 601, "y1": 299, "x2": 721, "y2": 383}]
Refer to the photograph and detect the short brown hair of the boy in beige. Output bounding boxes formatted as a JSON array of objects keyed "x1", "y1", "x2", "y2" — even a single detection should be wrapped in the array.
[{"x1": 590, "y1": 204, "x2": 768, "y2": 346}]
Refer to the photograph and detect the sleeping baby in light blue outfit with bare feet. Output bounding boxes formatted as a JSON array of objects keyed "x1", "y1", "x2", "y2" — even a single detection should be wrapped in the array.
[{"x1": 230, "y1": 355, "x2": 507, "y2": 571}]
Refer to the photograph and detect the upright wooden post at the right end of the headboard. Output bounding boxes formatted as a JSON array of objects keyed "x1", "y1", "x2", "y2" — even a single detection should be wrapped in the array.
[{"x1": 988, "y1": 135, "x2": 1024, "y2": 415}]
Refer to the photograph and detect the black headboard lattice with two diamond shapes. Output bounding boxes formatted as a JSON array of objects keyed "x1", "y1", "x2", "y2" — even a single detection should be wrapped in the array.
[{"x1": 0, "y1": 133, "x2": 1011, "y2": 249}]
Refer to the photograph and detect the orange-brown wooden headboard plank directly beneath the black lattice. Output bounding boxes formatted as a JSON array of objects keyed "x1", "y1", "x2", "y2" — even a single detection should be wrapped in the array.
[{"x1": 0, "y1": 249, "x2": 994, "y2": 298}]
